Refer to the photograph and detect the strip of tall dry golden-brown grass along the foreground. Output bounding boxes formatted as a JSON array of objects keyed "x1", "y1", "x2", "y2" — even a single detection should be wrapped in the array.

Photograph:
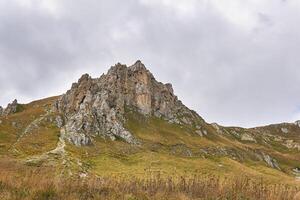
[{"x1": 0, "y1": 159, "x2": 300, "y2": 200}]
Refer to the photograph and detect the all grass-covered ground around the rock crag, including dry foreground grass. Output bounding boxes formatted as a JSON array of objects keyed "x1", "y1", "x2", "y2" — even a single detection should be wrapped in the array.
[{"x1": 0, "y1": 97, "x2": 300, "y2": 199}]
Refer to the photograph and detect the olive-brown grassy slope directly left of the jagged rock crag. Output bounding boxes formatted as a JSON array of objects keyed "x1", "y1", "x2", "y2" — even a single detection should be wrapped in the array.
[{"x1": 0, "y1": 97, "x2": 59, "y2": 158}]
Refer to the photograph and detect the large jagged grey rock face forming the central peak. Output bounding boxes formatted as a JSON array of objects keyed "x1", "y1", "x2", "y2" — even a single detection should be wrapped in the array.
[{"x1": 55, "y1": 61, "x2": 203, "y2": 145}]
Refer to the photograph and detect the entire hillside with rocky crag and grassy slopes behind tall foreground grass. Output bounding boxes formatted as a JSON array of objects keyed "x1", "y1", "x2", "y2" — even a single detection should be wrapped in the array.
[{"x1": 0, "y1": 61, "x2": 300, "y2": 199}]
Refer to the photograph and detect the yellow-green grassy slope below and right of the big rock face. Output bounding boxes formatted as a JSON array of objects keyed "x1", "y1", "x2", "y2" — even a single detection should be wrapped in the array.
[{"x1": 68, "y1": 108, "x2": 297, "y2": 184}]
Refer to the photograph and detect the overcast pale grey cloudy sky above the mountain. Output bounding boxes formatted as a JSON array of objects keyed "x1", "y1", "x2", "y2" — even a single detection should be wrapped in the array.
[{"x1": 0, "y1": 0, "x2": 300, "y2": 127}]
